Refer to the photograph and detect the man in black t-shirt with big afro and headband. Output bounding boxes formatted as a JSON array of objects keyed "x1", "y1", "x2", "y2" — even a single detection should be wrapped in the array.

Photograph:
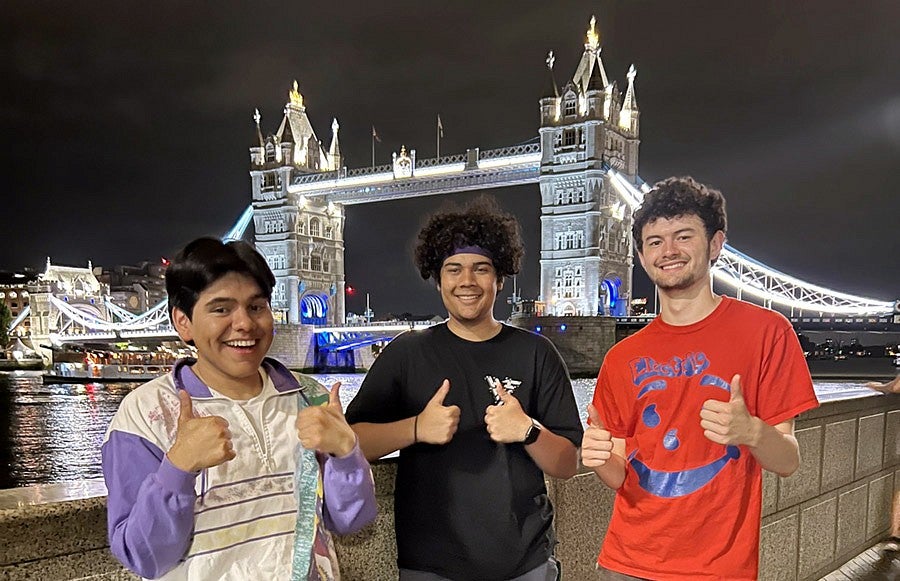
[{"x1": 347, "y1": 197, "x2": 582, "y2": 581}]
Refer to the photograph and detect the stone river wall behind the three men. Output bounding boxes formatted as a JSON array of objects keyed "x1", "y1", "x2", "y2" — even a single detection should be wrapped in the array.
[{"x1": 0, "y1": 392, "x2": 900, "y2": 581}]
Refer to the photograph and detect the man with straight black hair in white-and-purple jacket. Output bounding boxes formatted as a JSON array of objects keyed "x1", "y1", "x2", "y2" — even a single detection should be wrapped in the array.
[{"x1": 102, "y1": 238, "x2": 376, "y2": 581}]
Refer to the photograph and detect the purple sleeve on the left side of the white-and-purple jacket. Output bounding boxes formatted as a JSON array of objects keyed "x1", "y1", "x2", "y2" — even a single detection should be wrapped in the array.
[{"x1": 103, "y1": 434, "x2": 196, "y2": 578}]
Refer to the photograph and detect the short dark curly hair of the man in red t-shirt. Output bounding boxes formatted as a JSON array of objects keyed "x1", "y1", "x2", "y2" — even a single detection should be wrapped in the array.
[{"x1": 631, "y1": 176, "x2": 728, "y2": 252}]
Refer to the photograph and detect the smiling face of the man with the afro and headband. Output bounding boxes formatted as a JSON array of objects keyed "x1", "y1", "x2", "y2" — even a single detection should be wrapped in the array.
[{"x1": 438, "y1": 254, "x2": 503, "y2": 337}]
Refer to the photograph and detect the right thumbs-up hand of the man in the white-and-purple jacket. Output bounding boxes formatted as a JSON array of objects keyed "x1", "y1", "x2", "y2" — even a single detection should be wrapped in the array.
[{"x1": 295, "y1": 381, "x2": 356, "y2": 456}]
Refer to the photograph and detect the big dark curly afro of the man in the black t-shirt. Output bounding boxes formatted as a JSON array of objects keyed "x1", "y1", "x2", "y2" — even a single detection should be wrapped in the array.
[{"x1": 415, "y1": 195, "x2": 525, "y2": 283}]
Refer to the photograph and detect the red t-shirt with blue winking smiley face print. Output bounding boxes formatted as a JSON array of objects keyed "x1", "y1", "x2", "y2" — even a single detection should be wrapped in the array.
[{"x1": 593, "y1": 297, "x2": 818, "y2": 579}]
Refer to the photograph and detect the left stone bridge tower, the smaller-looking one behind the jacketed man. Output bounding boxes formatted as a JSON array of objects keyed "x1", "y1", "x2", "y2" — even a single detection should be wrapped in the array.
[{"x1": 250, "y1": 81, "x2": 344, "y2": 324}]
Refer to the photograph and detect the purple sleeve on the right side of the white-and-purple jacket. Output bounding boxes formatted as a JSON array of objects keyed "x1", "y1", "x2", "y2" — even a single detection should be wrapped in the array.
[{"x1": 322, "y1": 444, "x2": 377, "y2": 535}]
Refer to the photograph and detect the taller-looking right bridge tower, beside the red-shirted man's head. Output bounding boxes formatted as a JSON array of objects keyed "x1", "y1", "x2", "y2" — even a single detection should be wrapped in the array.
[{"x1": 540, "y1": 18, "x2": 640, "y2": 315}]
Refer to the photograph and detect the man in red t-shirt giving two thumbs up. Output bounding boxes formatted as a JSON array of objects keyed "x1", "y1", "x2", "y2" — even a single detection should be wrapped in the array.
[{"x1": 582, "y1": 178, "x2": 818, "y2": 580}]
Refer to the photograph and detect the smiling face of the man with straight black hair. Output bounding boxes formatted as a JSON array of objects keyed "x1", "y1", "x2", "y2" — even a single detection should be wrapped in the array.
[{"x1": 172, "y1": 272, "x2": 274, "y2": 398}]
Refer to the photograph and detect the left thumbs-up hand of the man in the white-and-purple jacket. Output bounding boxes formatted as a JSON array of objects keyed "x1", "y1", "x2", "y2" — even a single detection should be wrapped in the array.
[{"x1": 166, "y1": 389, "x2": 235, "y2": 472}]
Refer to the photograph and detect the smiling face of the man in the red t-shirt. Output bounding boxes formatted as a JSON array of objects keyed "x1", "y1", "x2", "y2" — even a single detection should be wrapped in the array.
[{"x1": 638, "y1": 214, "x2": 725, "y2": 294}]
